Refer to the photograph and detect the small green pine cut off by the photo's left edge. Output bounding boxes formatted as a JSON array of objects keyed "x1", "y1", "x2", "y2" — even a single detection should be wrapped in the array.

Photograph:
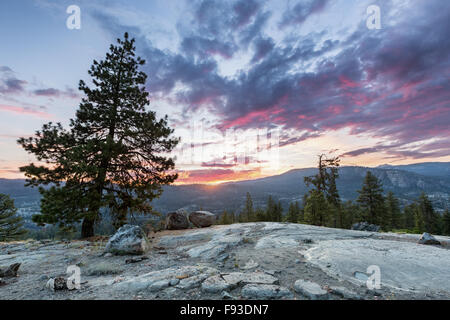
[{"x1": 0, "y1": 193, "x2": 27, "y2": 242}]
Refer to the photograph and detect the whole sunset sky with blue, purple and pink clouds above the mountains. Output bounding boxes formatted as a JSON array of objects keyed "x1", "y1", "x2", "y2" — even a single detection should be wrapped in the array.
[{"x1": 0, "y1": 0, "x2": 450, "y2": 184}]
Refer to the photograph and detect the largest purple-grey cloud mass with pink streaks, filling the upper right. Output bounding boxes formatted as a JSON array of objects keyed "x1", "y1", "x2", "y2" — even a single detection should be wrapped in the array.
[{"x1": 89, "y1": 0, "x2": 450, "y2": 162}]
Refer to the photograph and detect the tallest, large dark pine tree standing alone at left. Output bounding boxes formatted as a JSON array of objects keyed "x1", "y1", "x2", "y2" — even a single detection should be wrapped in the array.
[{"x1": 18, "y1": 33, "x2": 179, "y2": 237}]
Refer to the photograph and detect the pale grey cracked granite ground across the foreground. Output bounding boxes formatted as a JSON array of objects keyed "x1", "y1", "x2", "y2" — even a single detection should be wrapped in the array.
[{"x1": 0, "y1": 223, "x2": 450, "y2": 300}]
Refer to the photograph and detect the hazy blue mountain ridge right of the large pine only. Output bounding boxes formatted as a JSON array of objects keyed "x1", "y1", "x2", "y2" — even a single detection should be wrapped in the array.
[{"x1": 149, "y1": 166, "x2": 450, "y2": 212}]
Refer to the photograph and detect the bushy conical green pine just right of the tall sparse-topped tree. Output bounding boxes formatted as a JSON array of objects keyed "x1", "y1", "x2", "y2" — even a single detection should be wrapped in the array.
[{"x1": 357, "y1": 171, "x2": 385, "y2": 225}]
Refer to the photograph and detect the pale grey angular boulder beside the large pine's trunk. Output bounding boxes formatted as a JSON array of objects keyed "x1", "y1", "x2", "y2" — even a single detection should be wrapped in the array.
[{"x1": 105, "y1": 224, "x2": 150, "y2": 255}]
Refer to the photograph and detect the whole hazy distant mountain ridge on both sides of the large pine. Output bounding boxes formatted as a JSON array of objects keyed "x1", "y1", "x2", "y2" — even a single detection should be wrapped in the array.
[{"x1": 0, "y1": 162, "x2": 450, "y2": 225}]
